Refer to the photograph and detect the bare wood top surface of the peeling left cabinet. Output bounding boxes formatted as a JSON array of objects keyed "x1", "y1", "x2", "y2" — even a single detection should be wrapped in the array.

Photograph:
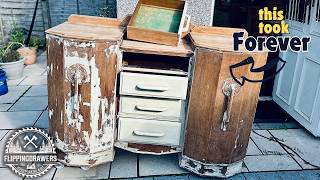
[{"x1": 46, "y1": 22, "x2": 124, "y2": 41}]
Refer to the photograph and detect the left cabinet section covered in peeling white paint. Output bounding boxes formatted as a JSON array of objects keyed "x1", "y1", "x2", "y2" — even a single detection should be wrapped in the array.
[{"x1": 46, "y1": 16, "x2": 124, "y2": 167}]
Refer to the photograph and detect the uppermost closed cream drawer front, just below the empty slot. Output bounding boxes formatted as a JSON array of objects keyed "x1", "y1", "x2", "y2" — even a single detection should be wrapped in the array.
[{"x1": 120, "y1": 72, "x2": 188, "y2": 99}]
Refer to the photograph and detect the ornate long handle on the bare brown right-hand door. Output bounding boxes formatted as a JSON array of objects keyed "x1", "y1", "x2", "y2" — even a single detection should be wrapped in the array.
[{"x1": 221, "y1": 79, "x2": 240, "y2": 131}]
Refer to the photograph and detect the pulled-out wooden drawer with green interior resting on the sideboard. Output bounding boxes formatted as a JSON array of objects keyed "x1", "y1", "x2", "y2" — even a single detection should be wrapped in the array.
[{"x1": 127, "y1": 0, "x2": 190, "y2": 46}]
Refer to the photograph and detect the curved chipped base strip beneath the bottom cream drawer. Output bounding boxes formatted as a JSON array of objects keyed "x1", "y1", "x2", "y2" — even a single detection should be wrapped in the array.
[{"x1": 115, "y1": 141, "x2": 181, "y2": 155}]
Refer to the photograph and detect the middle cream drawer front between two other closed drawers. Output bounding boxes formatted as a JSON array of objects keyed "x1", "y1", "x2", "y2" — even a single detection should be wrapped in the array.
[{"x1": 120, "y1": 96, "x2": 184, "y2": 121}]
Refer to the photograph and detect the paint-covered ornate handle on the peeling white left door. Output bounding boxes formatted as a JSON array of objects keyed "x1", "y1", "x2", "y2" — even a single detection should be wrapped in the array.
[{"x1": 67, "y1": 64, "x2": 87, "y2": 119}]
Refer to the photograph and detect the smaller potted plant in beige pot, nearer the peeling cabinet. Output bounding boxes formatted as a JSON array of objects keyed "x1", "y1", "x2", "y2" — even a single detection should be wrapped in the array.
[{"x1": 10, "y1": 27, "x2": 42, "y2": 65}]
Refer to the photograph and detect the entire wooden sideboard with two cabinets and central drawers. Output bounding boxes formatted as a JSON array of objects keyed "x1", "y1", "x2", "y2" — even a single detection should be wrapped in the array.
[{"x1": 47, "y1": 16, "x2": 267, "y2": 177}]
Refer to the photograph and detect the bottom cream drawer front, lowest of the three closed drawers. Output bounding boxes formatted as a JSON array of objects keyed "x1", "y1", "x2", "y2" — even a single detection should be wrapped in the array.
[{"x1": 119, "y1": 117, "x2": 181, "y2": 146}]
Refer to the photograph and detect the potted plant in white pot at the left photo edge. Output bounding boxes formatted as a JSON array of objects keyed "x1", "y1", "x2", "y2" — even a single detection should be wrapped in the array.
[{"x1": 0, "y1": 42, "x2": 24, "y2": 79}]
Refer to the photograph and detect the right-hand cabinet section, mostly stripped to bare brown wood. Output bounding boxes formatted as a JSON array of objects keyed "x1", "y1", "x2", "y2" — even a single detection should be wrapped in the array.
[{"x1": 180, "y1": 27, "x2": 267, "y2": 178}]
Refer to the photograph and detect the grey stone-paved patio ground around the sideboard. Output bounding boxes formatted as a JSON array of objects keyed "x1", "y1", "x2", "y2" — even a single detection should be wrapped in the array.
[{"x1": 0, "y1": 53, "x2": 320, "y2": 180}]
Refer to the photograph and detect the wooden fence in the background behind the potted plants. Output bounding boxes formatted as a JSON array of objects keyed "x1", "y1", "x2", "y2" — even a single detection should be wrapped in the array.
[{"x1": 0, "y1": 0, "x2": 116, "y2": 40}]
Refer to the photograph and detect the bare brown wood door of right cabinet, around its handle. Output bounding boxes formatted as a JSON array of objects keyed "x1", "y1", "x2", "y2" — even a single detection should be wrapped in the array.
[{"x1": 183, "y1": 48, "x2": 267, "y2": 164}]
